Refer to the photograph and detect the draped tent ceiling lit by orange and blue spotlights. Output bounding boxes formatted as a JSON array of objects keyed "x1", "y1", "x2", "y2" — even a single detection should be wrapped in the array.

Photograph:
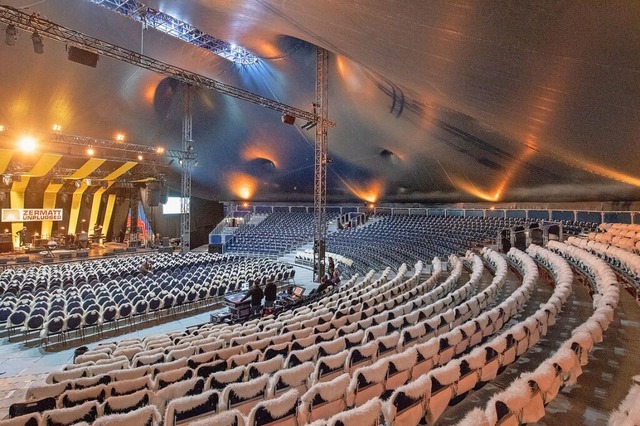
[{"x1": 0, "y1": 0, "x2": 640, "y2": 201}]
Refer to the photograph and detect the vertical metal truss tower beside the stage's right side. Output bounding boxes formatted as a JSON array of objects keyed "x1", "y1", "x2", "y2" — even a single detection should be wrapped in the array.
[{"x1": 180, "y1": 84, "x2": 194, "y2": 253}]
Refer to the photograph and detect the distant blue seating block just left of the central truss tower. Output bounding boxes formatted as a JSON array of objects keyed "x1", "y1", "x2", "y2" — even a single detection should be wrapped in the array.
[{"x1": 226, "y1": 212, "x2": 322, "y2": 255}]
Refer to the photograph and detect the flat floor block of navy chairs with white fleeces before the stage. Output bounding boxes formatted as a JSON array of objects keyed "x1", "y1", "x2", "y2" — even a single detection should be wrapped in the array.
[{"x1": 0, "y1": 253, "x2": 290, "y2": 339}]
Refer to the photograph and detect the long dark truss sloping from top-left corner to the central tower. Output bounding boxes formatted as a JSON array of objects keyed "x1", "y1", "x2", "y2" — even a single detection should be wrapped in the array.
[{"x1": 0, "y1": 5, "x2": 335, "y2": 127}]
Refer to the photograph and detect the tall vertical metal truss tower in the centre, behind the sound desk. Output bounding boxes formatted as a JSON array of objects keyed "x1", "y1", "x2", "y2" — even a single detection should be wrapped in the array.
[{"x1": 313, "y1": 47, "x2": 329, "y2": 281}]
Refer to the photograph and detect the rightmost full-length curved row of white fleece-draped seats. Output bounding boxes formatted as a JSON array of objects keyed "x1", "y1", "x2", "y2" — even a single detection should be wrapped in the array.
[{"x1": 463, "y1": 241, "x2": 619, "y2": 425}]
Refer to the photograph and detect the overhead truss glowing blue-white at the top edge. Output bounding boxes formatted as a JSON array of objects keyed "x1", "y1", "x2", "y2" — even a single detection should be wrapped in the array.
[{"x1": 90, "y1": 0, "x2": 258, "y2": 65}]
